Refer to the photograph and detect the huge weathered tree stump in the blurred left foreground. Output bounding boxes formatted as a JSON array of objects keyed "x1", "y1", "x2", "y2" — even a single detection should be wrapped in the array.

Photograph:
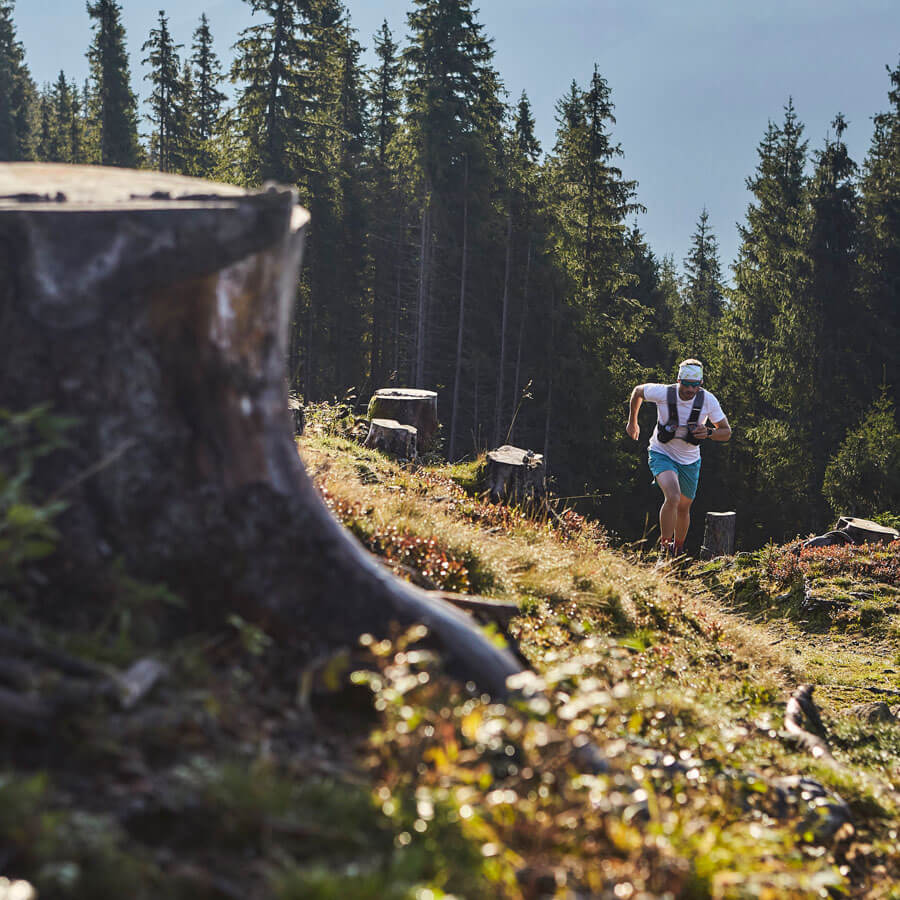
[{"x1": 0, "y1": 163, "x2": 521, "y2": 694}]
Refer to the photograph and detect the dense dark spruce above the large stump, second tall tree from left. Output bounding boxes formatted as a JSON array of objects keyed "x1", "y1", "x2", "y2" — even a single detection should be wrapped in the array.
[{"x1": 87, "y1": 0, "x2": 141, "y2": 166}]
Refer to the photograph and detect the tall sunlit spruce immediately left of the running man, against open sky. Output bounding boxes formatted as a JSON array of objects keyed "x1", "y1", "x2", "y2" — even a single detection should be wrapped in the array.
[{"x1": 549, "y1": 69, "x2": 646, "y2": 506}]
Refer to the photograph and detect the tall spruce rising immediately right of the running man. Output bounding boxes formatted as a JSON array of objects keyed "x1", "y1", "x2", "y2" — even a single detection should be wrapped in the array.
[{"x1": 720, "y1": 101, "x2": 817, "y2": 542}]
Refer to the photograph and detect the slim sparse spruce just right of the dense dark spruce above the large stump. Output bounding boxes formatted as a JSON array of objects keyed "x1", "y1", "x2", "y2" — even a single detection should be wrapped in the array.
[{"x1": 141, "y1": 10, "x2": 184, "y2": 172}]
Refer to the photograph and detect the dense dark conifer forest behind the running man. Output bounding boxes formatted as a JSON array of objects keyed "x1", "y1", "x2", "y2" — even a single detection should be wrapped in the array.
[{"x1": 0, "y1": 0, "x2": 900, "y2": 548}]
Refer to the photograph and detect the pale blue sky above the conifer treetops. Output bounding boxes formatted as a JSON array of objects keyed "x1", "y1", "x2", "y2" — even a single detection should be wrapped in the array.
[{"x1": 15, "y1": 0, "x2": 900, "y2": 278}]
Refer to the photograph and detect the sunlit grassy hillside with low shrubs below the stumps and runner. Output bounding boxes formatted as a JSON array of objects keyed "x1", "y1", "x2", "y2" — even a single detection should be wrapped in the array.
[{"x1": 0, "y1": 414, "x2": 900, "y2": 900}]
